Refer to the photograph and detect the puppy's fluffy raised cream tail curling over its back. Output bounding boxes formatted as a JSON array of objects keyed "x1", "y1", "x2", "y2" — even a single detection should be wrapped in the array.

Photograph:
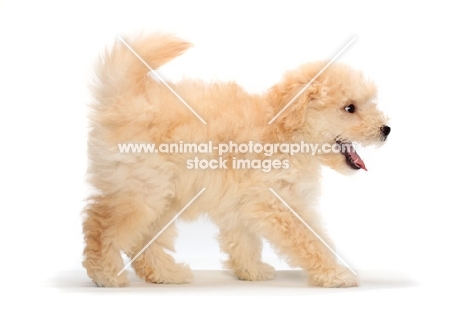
[{"x1": 94, "y1": 34, "x2": 191, "y2": 98}]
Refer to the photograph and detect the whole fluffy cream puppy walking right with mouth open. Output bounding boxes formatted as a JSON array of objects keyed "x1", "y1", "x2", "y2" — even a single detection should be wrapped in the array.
[{"x1": 83, "y1": 34, "x2": 390, "y2": 287}]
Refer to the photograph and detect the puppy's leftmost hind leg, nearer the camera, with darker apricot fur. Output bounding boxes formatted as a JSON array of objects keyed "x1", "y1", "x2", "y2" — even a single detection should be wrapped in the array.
[{"x1": 83, "y1": 192, "x2": 167, "y2": 287}]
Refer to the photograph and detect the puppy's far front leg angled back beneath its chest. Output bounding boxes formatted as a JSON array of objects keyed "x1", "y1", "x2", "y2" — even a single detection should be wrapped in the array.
[{"x1": 219, "y1": 226, "x2": 275, "y2": 281}]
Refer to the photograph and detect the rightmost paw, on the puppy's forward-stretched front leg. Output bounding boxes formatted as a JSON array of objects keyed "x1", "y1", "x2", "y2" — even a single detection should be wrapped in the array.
[{"x1": 309, "y1": 266, "x2": 358, "y2": 288}]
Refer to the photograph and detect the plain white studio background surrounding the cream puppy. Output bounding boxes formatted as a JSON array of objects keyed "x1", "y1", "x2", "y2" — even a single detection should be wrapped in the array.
[{"x1": 0, "y1": 1, "x2": 468, "y2": 309}]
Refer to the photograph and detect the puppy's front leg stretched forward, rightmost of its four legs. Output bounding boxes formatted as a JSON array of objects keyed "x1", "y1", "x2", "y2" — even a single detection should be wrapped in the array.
[{"x1": 243, "y1": 195, "x2": 358, "y2": 287}]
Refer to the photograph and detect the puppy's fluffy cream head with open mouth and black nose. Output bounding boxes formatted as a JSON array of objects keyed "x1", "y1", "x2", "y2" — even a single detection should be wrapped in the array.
[{"x1": 269, "y1": 62, "x2": 390, "y2": 173}]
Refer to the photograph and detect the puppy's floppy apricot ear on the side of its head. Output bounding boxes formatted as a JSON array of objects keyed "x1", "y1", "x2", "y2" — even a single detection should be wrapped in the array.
[{"x1": 270, "y1": 83, "x2": 320, "y2": 132}]
